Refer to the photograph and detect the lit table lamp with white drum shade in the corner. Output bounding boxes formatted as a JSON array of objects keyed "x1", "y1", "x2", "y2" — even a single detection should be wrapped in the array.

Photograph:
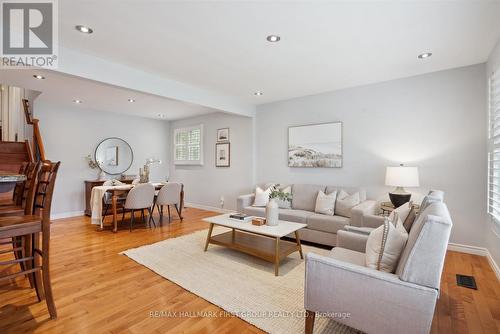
[{"x1": 385, "y1": 164, "x2": 419, "y2": 208}]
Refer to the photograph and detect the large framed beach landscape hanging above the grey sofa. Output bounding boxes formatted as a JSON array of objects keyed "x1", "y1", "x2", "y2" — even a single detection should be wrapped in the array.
[{"x1": 288, "y1": 122, "x2": 342, "y2": 168}]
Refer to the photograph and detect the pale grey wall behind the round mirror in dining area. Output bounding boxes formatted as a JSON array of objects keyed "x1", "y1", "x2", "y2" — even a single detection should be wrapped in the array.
[{"x1": 34, "y1": 101, "x2": 170, "y2": 216}]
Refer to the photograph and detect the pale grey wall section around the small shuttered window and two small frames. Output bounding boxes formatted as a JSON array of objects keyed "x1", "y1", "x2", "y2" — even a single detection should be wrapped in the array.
[{"x1": 170, "y1": 113, "x2": 254, "y2": 210}]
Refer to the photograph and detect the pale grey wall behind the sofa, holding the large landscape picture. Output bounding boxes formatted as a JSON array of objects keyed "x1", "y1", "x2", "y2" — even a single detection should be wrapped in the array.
[{"x1": 256, "y1": 64, "x2": 487, "y2": 246}]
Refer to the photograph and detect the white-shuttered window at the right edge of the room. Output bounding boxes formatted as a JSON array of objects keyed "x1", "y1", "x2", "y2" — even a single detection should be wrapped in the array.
[{"x1": 488, "y1": 68, "x2": 500, "y2": 224}]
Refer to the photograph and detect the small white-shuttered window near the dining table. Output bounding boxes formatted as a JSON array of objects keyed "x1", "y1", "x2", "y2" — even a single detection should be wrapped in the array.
[{"x1": 174, "y1": 124, "x2": 203, "y2": 165}]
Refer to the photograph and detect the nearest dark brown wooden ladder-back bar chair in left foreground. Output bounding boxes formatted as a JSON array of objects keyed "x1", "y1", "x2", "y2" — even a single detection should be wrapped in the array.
[{"x1": 0, "y1": 161, "x2": 61, "y2": 319}]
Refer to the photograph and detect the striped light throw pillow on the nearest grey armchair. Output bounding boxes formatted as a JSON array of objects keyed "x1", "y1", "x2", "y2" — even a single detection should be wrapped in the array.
[{"x1": 365, "y1": 218, "x2": 408, "y2": 273}]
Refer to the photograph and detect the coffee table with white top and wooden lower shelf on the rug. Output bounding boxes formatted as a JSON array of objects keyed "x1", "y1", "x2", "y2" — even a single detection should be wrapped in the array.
[{"x1": 203, "y1": 214, "x2": 307, "y2": 276}]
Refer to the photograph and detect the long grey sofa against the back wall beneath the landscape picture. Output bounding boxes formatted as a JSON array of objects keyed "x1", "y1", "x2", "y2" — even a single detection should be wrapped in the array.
[{"x1": 237, "y1": 184, "x2": 378, "y2": 246}]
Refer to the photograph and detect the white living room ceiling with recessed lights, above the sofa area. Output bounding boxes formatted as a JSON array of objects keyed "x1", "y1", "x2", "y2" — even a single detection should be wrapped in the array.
[{"x1": 59, "y1": 0, "x2": 500, "y2": 104}]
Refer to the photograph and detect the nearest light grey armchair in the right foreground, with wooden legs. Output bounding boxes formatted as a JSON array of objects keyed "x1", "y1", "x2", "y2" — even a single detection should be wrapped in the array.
[{"x1": 304, "y1": 202, "x2": 452, "y2": 334}]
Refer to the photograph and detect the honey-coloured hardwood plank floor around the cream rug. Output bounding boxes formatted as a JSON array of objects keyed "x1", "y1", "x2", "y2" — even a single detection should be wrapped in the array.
[{"x1": 0, "y1": 208, "x2": 500, "y2": 334}]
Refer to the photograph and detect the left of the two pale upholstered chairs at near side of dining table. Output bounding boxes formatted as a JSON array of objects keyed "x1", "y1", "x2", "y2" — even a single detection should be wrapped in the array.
[{"x1": 124, "y1": 183, "x2": 156, "y2": 232}]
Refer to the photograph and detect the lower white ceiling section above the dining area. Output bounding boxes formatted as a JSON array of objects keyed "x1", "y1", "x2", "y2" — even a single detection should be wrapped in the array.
[{"x1": 0, "y1": 70, "x2": 218, "y2": 120}]
